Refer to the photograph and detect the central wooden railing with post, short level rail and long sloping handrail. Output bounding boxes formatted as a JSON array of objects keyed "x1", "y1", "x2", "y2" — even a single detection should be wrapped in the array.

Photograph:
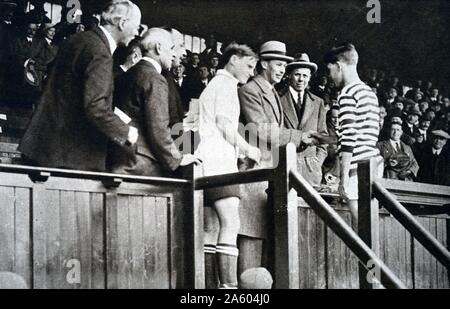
[{"x1": 195, "y1": 145, "x2": 405, "y2": 289}]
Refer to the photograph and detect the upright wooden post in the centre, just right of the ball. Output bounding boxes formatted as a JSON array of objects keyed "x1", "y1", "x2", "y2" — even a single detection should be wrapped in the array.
[{"x1": 270, "y1": 144, "x2": 299, "y2": 289}]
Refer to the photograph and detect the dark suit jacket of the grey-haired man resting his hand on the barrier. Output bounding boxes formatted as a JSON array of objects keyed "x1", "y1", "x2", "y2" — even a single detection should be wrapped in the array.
[{"x1": 111, "y1": 60, "x2": 182, "y2": 176}]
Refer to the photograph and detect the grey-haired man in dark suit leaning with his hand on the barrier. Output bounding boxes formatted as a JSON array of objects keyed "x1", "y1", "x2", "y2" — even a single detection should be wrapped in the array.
[{"x1": 108, "y1": 28, "x2": 197, "y2": 176}]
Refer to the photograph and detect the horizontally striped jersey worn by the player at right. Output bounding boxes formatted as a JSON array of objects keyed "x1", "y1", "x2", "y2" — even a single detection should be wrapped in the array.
[{"x1": 337, "y1": 82, "x2": 380, "y2": 176}]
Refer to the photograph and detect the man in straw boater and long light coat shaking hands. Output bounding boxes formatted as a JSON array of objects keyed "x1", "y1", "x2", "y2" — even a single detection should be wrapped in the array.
[{"x1": 239, "y1": 41, "x2": 311, "y2": 273}]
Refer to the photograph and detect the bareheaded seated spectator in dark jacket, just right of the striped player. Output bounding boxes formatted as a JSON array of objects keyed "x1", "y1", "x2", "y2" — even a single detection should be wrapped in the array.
[{"x1": 377, "y1": 122, "x2": 419, "y2": 181}]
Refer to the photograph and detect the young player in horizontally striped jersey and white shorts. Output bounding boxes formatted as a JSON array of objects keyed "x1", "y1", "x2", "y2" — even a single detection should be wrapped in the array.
[{"x1": 318, "y1": 43, "x2": 383, "y2": 219}]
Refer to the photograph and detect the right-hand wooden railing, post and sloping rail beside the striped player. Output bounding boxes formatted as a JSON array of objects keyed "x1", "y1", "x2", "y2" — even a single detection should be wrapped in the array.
[{"x1": 358, "y1": 160, "x2": 450, "y2": 288}]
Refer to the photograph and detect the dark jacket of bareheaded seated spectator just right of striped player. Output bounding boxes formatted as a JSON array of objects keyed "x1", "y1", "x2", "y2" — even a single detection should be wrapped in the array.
[{"x1": 377, "y1": 139, "x2": 419, "y2": 181}]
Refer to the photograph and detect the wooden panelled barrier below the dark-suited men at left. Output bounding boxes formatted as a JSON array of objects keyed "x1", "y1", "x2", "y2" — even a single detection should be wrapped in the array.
[{"x1": 0, "y1": 165, "x2": 197, "y2": 289}]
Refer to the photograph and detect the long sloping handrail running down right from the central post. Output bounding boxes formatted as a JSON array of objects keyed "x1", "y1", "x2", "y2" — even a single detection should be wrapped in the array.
[{"x1": 290, "y1": 171, "x2": 406, "y2": 289}]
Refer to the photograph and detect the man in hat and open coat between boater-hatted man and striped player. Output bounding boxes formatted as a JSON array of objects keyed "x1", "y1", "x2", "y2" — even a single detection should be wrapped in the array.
[{"x1": 279, "y1": 53, "x2": 328, "y2": 186}]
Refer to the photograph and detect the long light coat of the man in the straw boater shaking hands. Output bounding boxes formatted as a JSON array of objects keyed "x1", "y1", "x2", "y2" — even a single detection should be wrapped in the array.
[{"x1": 238, "y1": 75, "x2": 302, "y2": 238}]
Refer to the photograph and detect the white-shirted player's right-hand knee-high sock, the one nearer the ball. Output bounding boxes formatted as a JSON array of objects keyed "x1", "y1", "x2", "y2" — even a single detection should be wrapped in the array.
[{"x1": 217, "y1": 244, "x2": 239, "y2": 288}]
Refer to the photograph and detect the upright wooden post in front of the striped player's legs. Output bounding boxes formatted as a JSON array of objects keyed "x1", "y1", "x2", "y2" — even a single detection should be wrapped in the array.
[{"x1": 358, "y1": 158, "x2": 380, "y2": 289}]
